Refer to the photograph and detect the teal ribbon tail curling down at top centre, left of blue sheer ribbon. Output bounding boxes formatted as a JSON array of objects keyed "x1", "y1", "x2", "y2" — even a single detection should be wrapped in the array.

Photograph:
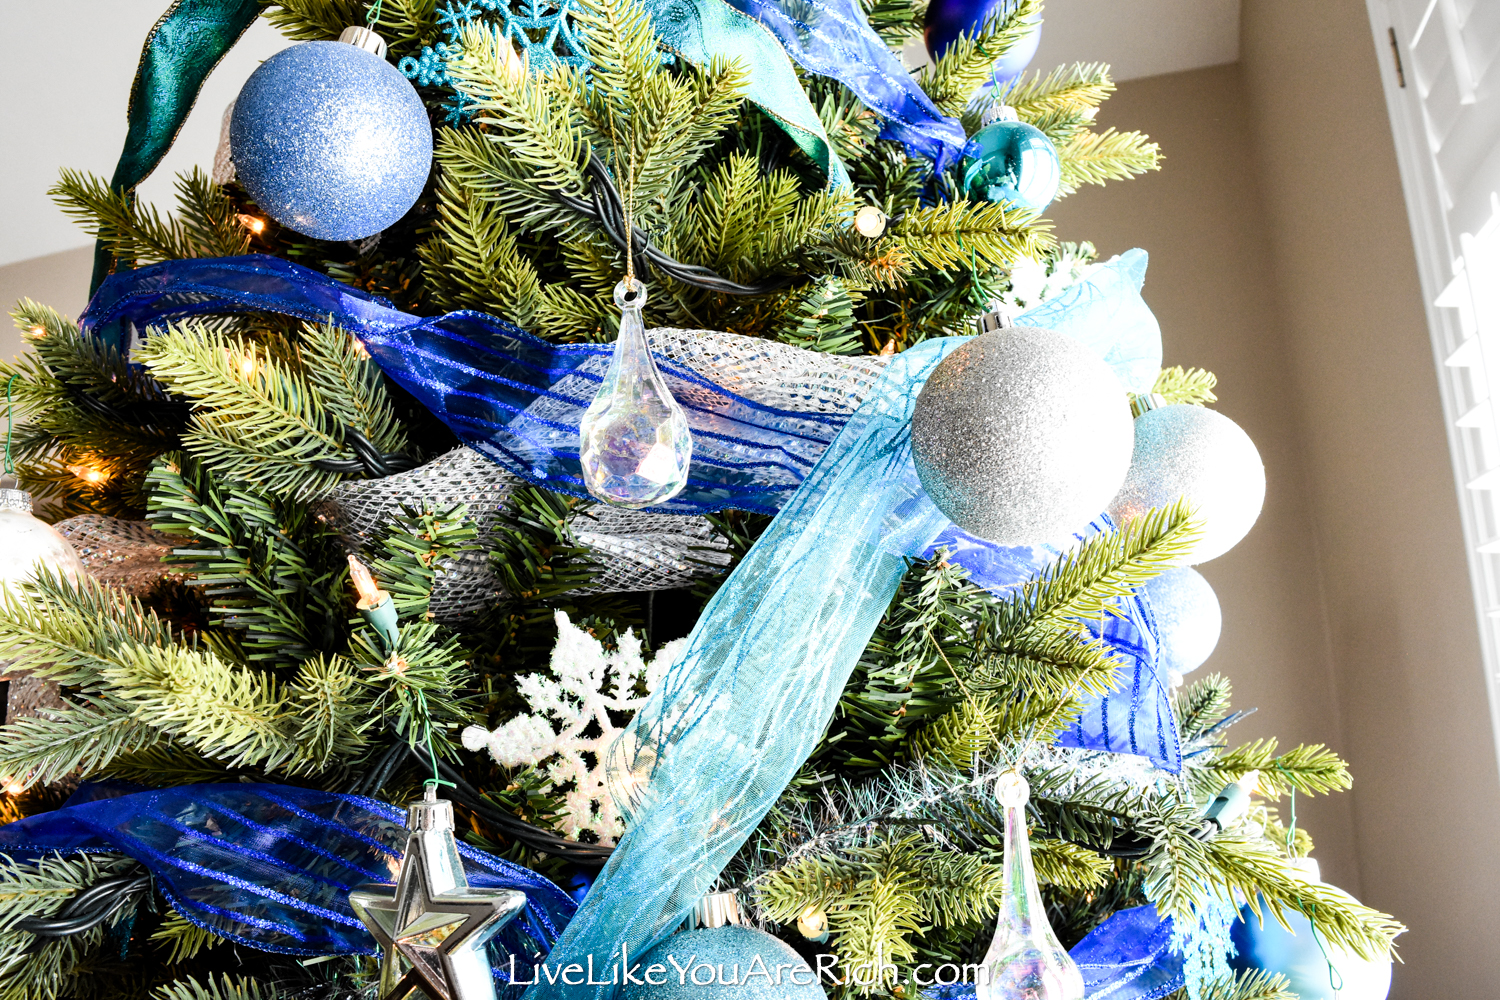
[{"x1": 645, "y1": 0, "x2": 851, "y2": 190}]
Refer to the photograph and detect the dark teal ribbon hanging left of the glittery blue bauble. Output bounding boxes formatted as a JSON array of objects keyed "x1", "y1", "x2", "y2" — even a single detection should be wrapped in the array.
[{"x1": 89, "y1": 0, "x2": 261, "y2": 295}]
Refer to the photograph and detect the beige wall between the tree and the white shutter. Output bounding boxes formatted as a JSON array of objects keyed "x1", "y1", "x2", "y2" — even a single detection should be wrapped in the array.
[{"x1": 1052, "y1": 0, "x2": 1500, "y2": 1000}]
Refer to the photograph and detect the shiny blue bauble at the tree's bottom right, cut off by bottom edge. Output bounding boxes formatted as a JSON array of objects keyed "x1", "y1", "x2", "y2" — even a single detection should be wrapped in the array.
[{"x1": 1230, "y1": 906, "x2": 1391, "y2": 1000}]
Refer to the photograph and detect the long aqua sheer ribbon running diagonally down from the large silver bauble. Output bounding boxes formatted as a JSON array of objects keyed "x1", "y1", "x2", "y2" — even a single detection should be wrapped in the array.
[{"x1": 527, "y1": 337, "x2": 968, "y2": 1000}]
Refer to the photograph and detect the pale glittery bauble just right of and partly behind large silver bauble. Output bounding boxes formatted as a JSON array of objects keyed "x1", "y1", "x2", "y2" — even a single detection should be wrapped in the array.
[{"x1": 1109, "y1": 403, "x2": 1266, "y2": 565}]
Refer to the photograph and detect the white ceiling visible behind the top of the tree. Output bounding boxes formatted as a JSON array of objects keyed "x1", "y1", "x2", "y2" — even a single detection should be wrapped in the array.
[{"x1": 0, "y1": 0, "x2": 1239, "y2": 267}]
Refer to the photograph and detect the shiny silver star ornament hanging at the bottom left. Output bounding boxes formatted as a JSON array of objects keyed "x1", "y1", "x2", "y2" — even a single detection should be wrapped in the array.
[{"x1": 350, "y1": 783, "x2": 527, "y2": 1000}]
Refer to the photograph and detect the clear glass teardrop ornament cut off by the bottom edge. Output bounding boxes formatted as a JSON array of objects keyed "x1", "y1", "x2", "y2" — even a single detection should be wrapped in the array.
[{"x1": 975, "y1": 771, "x2": 1083, "y2": 1000}]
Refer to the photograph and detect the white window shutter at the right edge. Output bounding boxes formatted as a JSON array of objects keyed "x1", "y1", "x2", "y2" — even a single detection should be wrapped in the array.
[{"x1": 1367, "y1": 0, "x2": 1500, "y2": 747}]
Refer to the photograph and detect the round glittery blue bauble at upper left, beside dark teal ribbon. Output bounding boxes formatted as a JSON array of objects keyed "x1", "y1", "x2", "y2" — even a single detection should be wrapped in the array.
[{"x1": 230, "y1": 42, "x2": 432, "y2": 240}]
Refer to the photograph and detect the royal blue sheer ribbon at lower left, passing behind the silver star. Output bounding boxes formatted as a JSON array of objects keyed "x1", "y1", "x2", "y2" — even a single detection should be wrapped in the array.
[{"x1": 0, "y1": 784, "x2": 576, "y2": 978}]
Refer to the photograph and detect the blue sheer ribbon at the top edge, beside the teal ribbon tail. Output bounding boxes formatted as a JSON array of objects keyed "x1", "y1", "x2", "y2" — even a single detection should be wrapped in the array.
[{"x1": 728, "y1": 0, "x2": 968, "y2": 169}]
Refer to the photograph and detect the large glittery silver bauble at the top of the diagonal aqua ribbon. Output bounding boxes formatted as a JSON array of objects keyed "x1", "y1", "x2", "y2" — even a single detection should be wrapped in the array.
[{"x1": 912, "y1": 327, "x2": 1131, "y2": 546}]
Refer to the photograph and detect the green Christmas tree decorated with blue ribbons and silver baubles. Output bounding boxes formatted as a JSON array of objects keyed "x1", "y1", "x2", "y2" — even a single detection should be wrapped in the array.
[{"x1": 0, "y1": 0, "x2": 1403, "y2": 1000}]
